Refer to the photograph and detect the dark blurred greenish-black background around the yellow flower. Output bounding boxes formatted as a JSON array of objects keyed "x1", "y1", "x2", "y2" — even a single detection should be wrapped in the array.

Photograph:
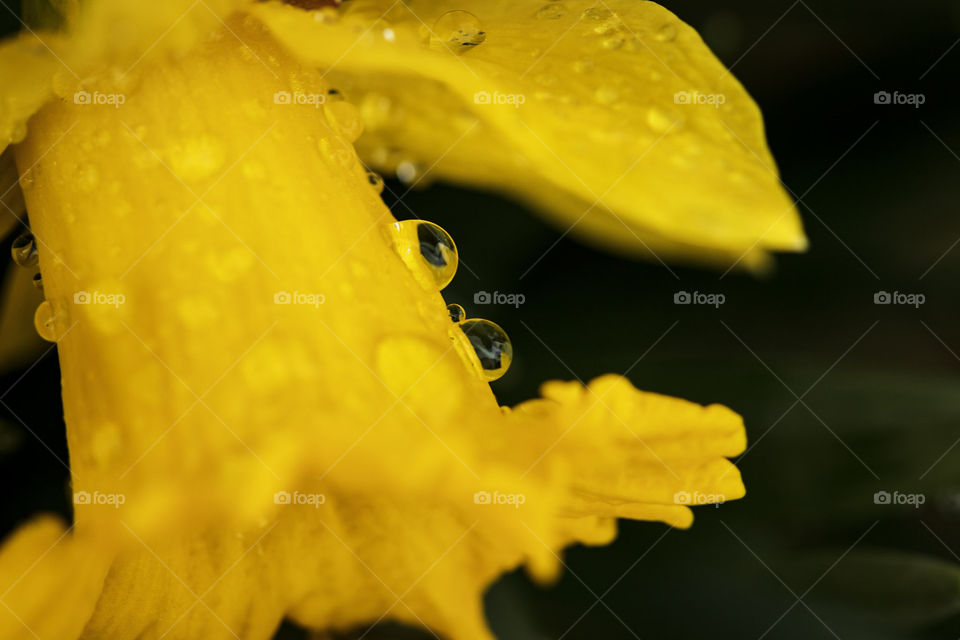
[{"x1": 0, "y1": 0, "x2": 960, "y2": 640}]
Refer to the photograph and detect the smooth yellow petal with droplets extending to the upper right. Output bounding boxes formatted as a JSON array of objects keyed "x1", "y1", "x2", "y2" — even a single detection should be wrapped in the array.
[{"x1": 252, "y1": 0, "x2": 806, "y2": 265}]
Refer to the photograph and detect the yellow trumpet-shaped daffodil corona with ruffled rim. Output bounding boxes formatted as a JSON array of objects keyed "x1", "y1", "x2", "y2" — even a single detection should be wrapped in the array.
[{"x1": 0, "y1": 10, "x2": 743, "y2": 640}]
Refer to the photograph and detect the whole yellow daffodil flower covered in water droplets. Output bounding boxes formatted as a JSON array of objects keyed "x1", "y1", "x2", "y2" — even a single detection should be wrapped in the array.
[{"x1": 0, "y1": 0, "x2": 804, "y2": 640}]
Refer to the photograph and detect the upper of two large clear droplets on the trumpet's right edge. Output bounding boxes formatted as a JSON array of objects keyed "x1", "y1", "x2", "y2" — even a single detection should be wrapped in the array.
[{"x1": 389, "y1": 220, "x2": 459, "y2": 289}]
